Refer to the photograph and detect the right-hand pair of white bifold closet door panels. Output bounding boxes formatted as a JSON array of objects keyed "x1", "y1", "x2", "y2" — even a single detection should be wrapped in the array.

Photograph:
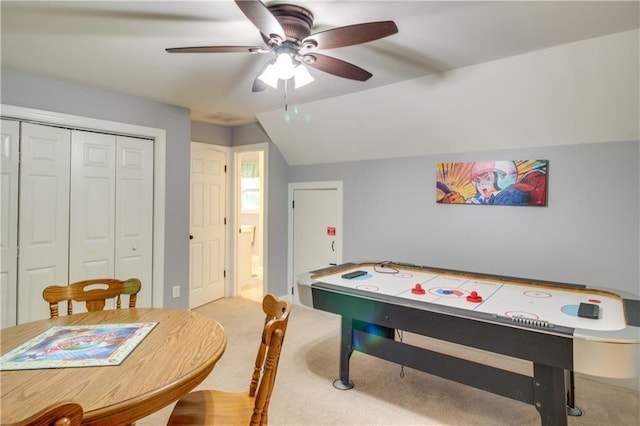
[{"x1": 69, "y1": 131, "x2": 153, "y2": 312}]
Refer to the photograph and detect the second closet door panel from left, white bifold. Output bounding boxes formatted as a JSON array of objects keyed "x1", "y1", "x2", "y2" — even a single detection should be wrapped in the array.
[{"x1": 18, "y1": 123, "x2": 71, "y2": 323}]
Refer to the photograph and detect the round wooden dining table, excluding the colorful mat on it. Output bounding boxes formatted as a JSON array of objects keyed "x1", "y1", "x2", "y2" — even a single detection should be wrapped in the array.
[{"x1": 0, "y1": 308, "x2": 227, "y2": 426}]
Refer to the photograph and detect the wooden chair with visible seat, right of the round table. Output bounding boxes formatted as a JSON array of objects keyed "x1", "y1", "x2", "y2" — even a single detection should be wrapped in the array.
[{"x1": 168, "y1": 294, "x2": 291, "y2": 426}]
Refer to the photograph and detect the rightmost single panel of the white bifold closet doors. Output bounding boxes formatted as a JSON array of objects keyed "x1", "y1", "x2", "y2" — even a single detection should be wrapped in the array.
[{"x1": 115, "y1": 136, "x2": 153, "y2": 307}]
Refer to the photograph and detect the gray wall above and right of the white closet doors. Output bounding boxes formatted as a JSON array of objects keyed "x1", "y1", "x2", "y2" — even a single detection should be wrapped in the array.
[{"x1": 0, "y1": 68, "x2": 191, "y2": 309}]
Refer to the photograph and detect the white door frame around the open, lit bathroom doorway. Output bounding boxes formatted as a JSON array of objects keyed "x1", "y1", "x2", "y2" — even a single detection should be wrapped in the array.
[{"x1": 231, "y1": 142, "x2": 269, "y2": 297}]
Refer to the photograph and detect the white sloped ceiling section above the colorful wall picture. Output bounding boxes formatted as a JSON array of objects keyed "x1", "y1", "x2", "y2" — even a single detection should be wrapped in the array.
[{"x1": 258, "y1": 30, "x2": 640, "y2": 165}]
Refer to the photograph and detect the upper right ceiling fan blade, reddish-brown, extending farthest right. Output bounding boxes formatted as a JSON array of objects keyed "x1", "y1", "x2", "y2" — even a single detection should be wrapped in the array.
[{"x1": 302, "y1": 21, "x2": 398, "y2": 49}]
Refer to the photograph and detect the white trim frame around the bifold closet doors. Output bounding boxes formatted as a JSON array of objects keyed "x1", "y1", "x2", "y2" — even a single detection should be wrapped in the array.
[{"x1": 0, "y1": 104, "x2": 167, "y2": 308}]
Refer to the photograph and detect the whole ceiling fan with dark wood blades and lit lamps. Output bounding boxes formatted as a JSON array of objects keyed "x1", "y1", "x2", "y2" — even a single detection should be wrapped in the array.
[{"x1": 166, "y1": 0, "x2": 398, "y2": 92}]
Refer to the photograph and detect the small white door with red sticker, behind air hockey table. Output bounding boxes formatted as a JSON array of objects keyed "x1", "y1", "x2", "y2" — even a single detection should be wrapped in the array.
[{"x1": 292, "y1": 188, "x2": 342, "y2": 302}]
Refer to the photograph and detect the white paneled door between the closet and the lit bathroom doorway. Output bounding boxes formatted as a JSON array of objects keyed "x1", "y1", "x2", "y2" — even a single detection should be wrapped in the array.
[{"x1": 189, "y1": 142, "x2": 226, "y2": 308}]
